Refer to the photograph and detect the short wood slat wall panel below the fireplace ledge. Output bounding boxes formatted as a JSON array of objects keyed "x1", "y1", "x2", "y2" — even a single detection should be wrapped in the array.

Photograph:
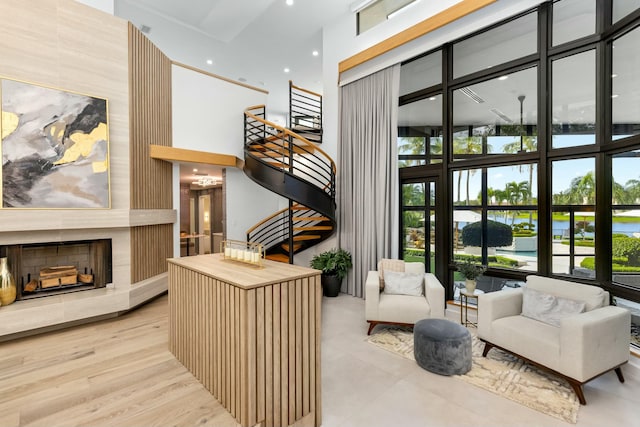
[{"x1": 131, "y1": 224, "x2": 173, "y2": 283}]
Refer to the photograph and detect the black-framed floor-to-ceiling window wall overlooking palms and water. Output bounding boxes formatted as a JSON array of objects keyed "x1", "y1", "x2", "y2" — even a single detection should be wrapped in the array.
[{"x1": 398, "y1": 0, "x2": 640, "y2": 320}]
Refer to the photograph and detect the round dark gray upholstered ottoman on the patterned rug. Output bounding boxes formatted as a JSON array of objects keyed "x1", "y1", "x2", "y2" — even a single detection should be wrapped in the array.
[{"x1": 413, "y1": 319, "x2": 471, "y2": 375}]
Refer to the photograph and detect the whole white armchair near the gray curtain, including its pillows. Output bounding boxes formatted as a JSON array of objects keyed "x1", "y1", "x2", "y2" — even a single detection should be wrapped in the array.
[{"x1": 365, "y1": 259, "x2": 445, "y2": 335}]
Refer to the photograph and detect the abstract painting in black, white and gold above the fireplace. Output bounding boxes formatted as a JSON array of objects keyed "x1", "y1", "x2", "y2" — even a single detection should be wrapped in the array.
[{"x1": 0, "y1": 79, "x2": 111, "y2": 209}]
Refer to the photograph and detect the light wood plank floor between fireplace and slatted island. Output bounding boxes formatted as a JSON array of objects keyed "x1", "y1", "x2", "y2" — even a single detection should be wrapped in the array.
[{"x1": 0, "y1": 295, "x2": 237, "y2": 427}]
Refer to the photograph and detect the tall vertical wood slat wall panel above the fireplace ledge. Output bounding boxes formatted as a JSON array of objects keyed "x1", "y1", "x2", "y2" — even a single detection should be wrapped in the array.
[{"x1": 129, "y1": 23, "x2": 173, "y2": 209}]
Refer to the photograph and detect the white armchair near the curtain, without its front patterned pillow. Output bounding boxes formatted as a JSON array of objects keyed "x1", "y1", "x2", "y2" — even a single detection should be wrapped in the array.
[{"x1": 365, "y1": 260, "x2": 445, "y2": 335}]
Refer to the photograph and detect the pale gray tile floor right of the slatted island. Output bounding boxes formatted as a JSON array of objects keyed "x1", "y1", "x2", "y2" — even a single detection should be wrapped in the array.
[{"x1": 322, "y1": 294, "x2": 640, "y2": 427}]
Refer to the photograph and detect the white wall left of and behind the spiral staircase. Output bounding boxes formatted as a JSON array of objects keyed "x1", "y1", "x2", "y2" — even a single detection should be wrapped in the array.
[{"x1": 172, "y1": 65, "x2": 283, "y2": 244}]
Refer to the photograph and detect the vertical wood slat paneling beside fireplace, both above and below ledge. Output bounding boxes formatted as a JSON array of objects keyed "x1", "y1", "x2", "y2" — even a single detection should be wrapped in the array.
[{"x1": 129, "y1": 23, "x2": 173, "y2": 283}]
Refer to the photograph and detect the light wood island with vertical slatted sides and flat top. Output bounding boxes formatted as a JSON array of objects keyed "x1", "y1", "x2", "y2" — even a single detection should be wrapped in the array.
[{"x1": 168, "y1": 254, "x2": 322, "y2": 427}]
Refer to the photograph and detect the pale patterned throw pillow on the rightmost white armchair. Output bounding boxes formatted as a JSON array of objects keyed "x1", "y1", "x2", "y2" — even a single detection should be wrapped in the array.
[{"x1": 522, "y1": 287, "x2": 585, "y2": 327}]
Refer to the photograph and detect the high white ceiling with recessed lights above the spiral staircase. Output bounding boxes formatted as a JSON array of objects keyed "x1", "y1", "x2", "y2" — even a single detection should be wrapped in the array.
[{"x1": 115, "y1": 0, "x2": 355, "y2": 95}]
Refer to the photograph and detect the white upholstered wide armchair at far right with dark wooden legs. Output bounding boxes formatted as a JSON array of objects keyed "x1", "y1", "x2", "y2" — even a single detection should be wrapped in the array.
[{"x1": 478, "y1": 276, "x2": 631, "y2": 405}]
